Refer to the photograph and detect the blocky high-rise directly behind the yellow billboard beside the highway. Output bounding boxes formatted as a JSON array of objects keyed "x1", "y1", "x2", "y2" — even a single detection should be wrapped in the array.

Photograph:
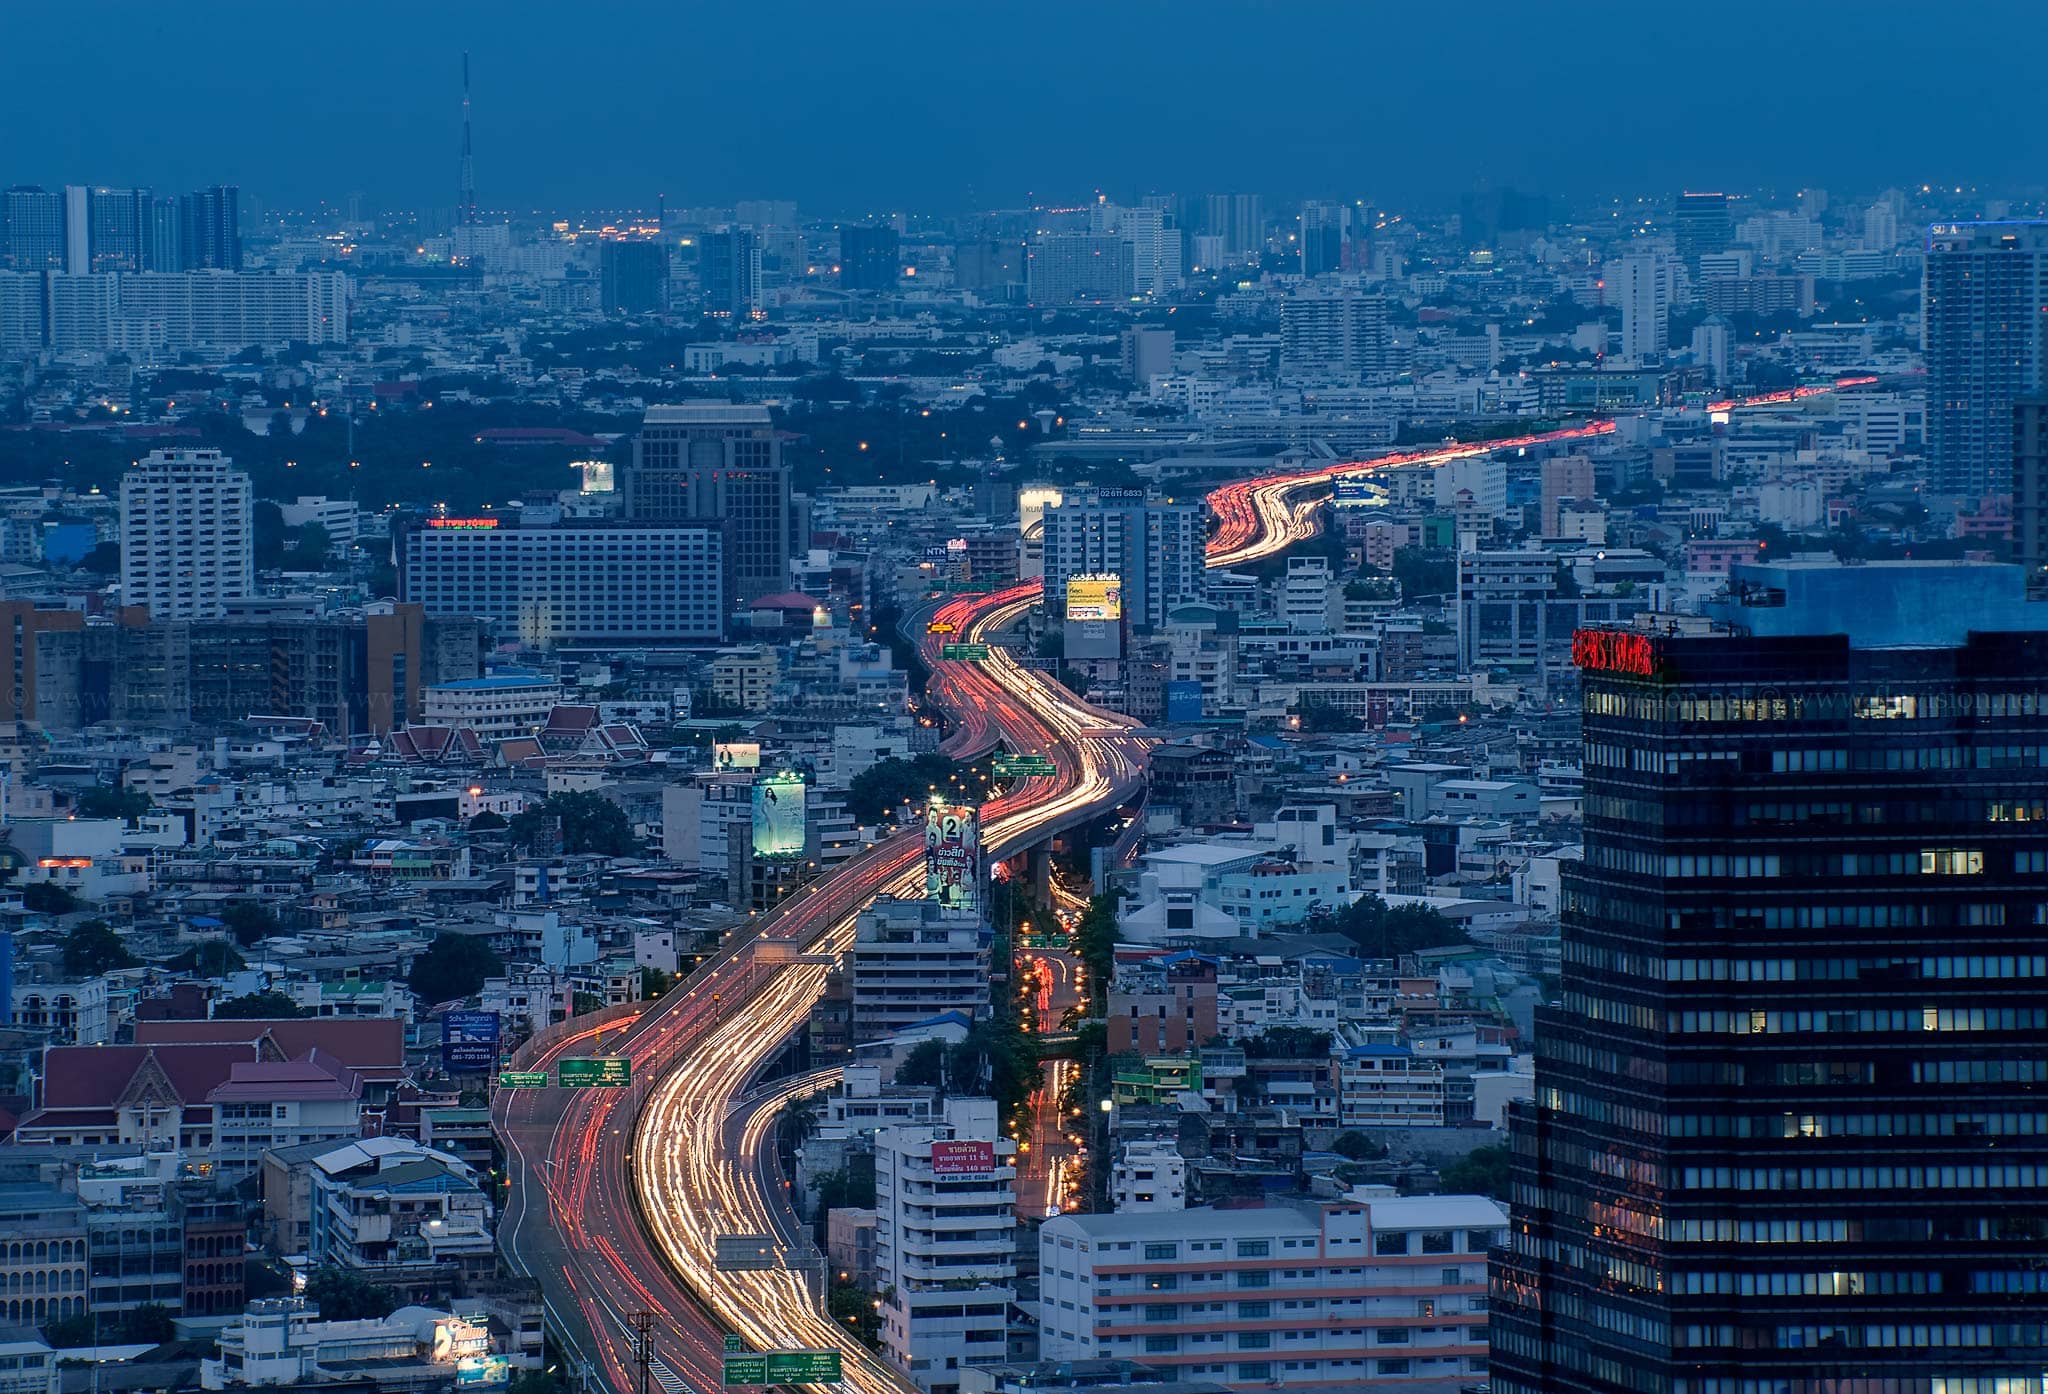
[{"x1": 1044, "y1": 489, "x2": 1208, "y2": 628}]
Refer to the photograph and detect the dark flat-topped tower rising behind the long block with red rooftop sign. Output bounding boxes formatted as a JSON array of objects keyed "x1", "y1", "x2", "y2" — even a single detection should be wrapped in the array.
[{"x1": 623, "y1": 401, "x2": 797, "y2": 602}]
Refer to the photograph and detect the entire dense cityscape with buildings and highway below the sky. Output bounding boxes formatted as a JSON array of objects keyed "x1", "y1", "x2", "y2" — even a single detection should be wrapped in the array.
[{"x1": 0, "y1": 16, "x2": 2048, "y2": 1394}]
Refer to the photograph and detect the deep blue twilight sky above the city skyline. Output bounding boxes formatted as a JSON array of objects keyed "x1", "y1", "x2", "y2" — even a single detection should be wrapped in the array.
[{"x1": 0, "y1": 0, "x2": 2048, "y2": 213}]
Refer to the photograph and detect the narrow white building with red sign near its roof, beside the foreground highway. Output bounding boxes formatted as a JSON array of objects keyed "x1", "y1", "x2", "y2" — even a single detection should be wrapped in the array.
[{"x1": 874, "y1": 1099, "x2": 1018, "y2": 1394}]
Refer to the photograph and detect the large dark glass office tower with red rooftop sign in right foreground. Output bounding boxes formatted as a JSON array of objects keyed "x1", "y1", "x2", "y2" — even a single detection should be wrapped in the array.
[{"x1": 1489, "y1": 561, "x2": 2048, "y2": 1394}]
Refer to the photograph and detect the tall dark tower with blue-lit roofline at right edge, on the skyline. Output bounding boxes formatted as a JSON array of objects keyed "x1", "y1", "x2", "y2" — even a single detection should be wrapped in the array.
[{"x1": 1921, "y1": 223, "x2": 2048, "y2": 497}]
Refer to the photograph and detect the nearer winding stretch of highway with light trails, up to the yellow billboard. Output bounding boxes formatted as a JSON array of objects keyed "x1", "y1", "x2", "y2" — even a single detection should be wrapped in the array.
[{"x1": 496, "y1": 583, "x2": 1145, "y2": 1392}]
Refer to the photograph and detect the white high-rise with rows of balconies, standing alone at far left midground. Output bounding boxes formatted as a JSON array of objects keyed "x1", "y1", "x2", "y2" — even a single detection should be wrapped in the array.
[{"x1": 121, "y1": 450, "x2": 256, "y2": 620}]
